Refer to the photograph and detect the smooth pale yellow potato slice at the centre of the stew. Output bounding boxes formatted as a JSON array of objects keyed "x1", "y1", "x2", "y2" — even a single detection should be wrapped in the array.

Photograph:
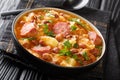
[{"x1": 41, "y1": 36, "x2": 58, "y2": 47}]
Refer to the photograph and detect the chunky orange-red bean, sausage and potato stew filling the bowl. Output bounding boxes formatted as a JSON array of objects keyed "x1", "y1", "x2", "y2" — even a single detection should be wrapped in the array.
[{"x1": 14, "y1": 9, "x2": 103, "y2": 67}]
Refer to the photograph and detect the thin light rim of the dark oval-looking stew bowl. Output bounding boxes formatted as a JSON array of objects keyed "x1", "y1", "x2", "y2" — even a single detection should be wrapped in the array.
[{"x1": 12, "y1": 7, "x2": 106, "y2": 69}]
